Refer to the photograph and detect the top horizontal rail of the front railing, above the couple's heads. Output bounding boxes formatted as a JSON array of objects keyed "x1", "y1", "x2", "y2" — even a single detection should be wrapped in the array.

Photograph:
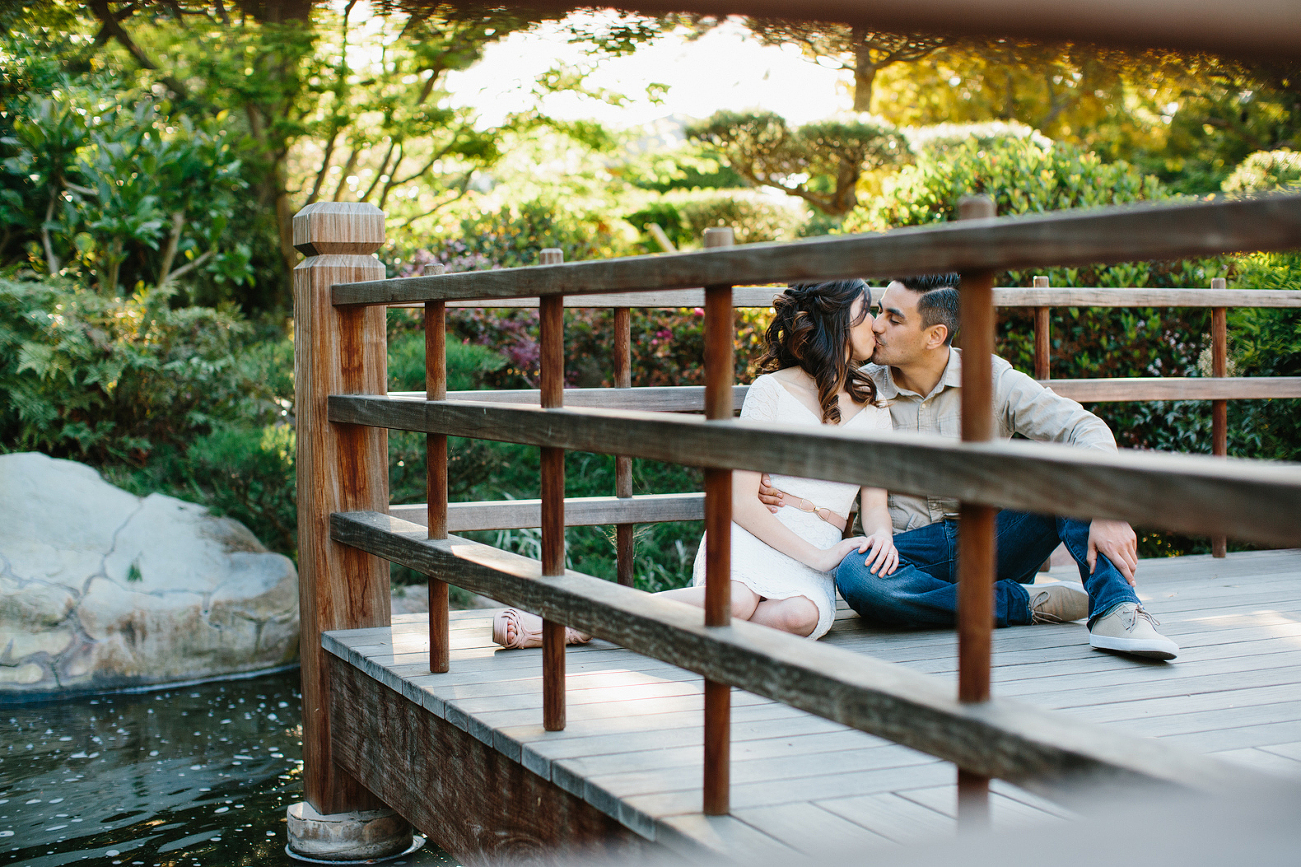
[{"x1": 332, "y1": 195, "x2": 1301, "y2": 305}]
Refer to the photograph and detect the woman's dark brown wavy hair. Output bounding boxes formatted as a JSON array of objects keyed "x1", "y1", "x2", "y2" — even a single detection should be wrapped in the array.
[{"x1": 758, "y1": 280, "x2": 877, "y2": 424}]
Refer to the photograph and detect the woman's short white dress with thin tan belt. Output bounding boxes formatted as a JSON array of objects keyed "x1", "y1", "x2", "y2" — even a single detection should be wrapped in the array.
[{"x1": 692, "y1": 374, "x2": 891, "y2": 638}]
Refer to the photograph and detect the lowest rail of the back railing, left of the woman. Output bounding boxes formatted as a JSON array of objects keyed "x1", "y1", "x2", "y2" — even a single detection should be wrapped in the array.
[{"x1": 389, "y1": 493, "x2": 705, "y2": 532}]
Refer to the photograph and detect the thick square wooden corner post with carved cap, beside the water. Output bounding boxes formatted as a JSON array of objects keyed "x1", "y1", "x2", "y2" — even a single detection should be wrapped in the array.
[{"x1": 294, "y1": 202, "x2": 390, "y2": 815}]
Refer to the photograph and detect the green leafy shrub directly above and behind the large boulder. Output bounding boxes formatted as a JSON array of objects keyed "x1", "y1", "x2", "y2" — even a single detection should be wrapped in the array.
[{"x1": 0, "y1": 280, "x2": 282, "y2": 462}]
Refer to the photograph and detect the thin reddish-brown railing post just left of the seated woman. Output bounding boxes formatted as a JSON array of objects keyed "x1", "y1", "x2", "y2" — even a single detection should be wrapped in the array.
[{"x1": 703, "y1": 228, "x2": 735, "y2": 816}]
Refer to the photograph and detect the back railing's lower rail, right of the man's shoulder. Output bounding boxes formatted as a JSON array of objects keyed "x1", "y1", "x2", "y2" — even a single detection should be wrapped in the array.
[{"x1": 1039, "y1": 376, "x2": 1301, "y2": 404}]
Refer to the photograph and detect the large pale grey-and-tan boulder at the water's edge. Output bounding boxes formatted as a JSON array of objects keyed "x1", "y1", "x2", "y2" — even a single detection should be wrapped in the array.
[{"x1": 0, "y1": 453, "x2": 298, "y2": 700}]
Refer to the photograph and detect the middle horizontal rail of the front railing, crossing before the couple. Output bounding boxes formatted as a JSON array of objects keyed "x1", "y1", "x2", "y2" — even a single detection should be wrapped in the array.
[{"x1": 329, "y1": 394, "x2": 1301, "y2": 547}]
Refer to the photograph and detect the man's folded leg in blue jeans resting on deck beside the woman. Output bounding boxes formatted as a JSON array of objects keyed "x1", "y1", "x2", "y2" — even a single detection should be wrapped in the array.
[{"x1": 835, "y1": 512, "x2": 1040, "y2": 629}]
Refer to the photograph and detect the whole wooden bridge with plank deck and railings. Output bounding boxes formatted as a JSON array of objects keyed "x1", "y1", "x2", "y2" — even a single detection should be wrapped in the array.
[{"x1": 284, "y1": 187, "x2": 1301, "y2": 862}]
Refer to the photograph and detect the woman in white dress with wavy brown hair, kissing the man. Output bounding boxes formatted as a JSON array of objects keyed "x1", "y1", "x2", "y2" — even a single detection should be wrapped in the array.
[{"x1": 493, "y1": 274, "x2": 899, "y2": 647}]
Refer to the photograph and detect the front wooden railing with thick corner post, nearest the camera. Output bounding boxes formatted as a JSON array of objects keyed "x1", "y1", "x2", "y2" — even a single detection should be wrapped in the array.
[{"x1": 295, "y1": 197, "x2": 1301, "y2": 815}]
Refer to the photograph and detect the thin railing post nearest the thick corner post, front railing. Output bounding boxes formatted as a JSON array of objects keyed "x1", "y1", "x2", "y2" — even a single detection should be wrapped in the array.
[{"x1": 424, "y1": 264, "x2": 451, "y2": 674}]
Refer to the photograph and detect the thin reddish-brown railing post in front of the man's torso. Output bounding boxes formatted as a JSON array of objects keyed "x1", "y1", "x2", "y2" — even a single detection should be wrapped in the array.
[{"x1": 958, "y1": 197, "x2": 998, "y2": 827}]
